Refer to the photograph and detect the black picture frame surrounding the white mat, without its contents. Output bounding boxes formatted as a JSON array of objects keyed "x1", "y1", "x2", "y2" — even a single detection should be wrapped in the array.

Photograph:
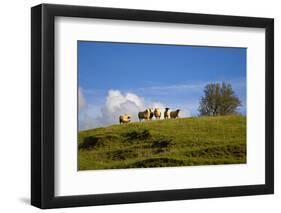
[{"x1": 31, "y1": 4, "x2": 274, "y2": 209}]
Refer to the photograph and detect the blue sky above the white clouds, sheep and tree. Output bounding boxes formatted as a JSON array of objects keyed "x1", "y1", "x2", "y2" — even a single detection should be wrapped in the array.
[{"x1": 78, "y1": 41, "x2": 246, "y2": 129}]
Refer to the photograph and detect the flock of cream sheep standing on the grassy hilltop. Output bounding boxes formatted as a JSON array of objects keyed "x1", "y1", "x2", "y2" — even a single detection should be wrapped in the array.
[{"x1": 119, "y1": 108, "x2": 180, "y2": 124}]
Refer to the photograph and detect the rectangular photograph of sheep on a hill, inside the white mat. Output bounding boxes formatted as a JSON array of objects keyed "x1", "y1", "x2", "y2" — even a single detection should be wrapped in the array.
[{"x1": 77, "y1": 41, "x2": 247, "y2": 170}]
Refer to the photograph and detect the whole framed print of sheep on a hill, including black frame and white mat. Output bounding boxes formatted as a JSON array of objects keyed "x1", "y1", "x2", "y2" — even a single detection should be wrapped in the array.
[{"x1": 31, "y1": 4, "x2": 274, "y2": 208}]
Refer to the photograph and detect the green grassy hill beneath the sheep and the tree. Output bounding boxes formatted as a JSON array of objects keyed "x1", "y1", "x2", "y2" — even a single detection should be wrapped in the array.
[{"x1": 78, "y1": 115, "x2": 246, "y2": 170}]
